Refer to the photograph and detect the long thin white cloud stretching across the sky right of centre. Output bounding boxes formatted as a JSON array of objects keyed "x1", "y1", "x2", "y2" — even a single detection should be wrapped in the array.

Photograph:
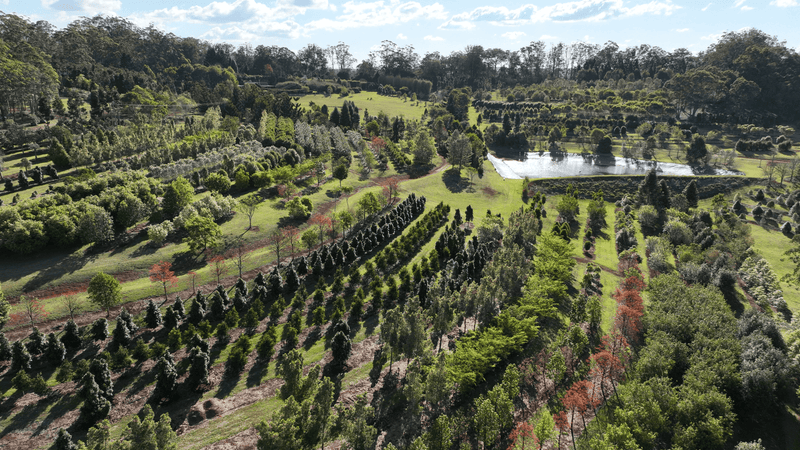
[{"x1": 439, "y1": 0, "x2": 681, "y2": 29}]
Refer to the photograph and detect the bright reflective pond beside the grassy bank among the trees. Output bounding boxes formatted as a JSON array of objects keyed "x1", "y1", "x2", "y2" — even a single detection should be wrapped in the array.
[{"x1": 489, "y1": 152, "x2": 744, "y2": 180}]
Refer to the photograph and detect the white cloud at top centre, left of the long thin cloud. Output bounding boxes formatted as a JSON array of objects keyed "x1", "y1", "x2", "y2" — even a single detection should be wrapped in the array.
[{"x1": 305, "y1": 0, "x2": 447, "y2": 31}]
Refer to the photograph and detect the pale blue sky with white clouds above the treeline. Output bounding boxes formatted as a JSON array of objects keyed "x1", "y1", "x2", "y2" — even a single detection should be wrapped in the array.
[{"x1": 6, "y1": 0, "x2": 800, "y2": 61}]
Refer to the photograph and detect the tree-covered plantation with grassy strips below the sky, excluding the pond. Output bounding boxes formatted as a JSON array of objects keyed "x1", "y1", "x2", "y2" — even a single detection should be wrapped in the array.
[{"x1": 0, "y1": 9, "x2": 800, "y2": 450}]
